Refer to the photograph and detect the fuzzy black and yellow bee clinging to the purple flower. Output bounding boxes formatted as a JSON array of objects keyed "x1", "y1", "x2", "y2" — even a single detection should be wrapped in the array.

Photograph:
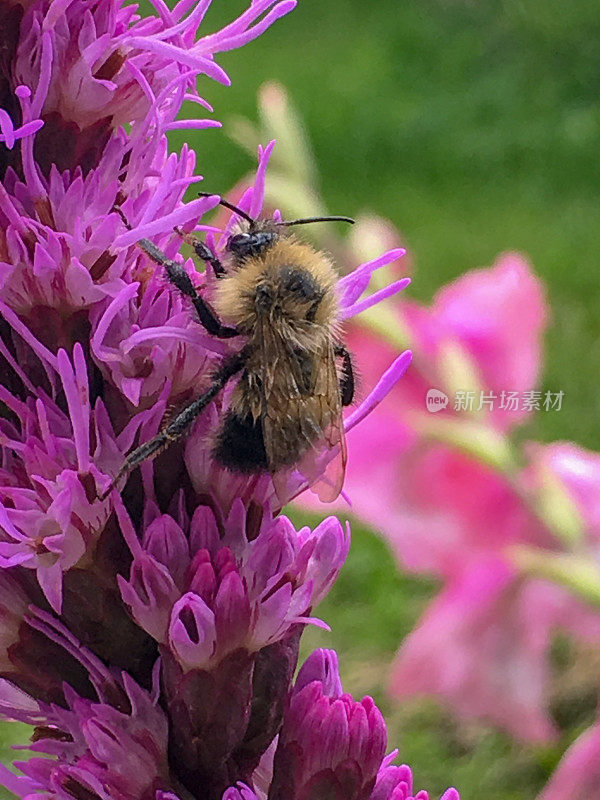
[{"x1": 103, "y1": 192, "x2": 354, "y2": 502}]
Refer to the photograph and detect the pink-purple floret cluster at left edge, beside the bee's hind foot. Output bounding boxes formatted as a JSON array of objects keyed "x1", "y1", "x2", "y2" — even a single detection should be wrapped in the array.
[{"x1": 0, "y1": 344, "x2": 117, "y2": 612}]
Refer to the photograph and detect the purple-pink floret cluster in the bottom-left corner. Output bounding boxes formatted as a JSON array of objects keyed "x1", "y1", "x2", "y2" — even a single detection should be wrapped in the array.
[{"x1": 0, "y1": 660, "x2": 170, "y2": 800}]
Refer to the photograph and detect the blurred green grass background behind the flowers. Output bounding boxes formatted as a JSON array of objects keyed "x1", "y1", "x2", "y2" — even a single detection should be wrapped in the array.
[{"x1": 4, "y1": 0, "x2": 600, "y2": 800}]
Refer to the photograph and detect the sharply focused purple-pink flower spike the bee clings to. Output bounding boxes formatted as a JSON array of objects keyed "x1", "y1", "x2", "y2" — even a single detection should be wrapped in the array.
[{"x1": 0, "y1": 0, "x2": 460, "y2": 800}]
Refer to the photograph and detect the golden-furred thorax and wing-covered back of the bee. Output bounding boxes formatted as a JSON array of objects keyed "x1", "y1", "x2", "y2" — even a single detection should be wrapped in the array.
[{"x1": 213, "y1": 228, "x2": 344, "y2": 499}]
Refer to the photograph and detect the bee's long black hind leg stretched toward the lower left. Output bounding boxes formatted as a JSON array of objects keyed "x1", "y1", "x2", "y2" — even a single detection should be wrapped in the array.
[{"x1": 99, "y1": 351, "x2": 245, "y2": 500}]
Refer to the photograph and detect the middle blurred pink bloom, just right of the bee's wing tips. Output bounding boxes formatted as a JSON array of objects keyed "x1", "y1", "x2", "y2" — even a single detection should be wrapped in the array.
[{"x1": 346, "y1": 438, "x2": 551, "y2": 579}]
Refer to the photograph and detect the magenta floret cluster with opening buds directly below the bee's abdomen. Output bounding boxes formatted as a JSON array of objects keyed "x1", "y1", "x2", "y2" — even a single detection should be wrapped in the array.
[{"x1": 118, "y1": 500, "x2": 350, "y2": 671}]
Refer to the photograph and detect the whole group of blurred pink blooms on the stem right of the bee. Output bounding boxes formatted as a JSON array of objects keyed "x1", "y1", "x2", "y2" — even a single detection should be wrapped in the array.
[{"x1": 303, "y1": 254, "x2": 600, "y2": 741}]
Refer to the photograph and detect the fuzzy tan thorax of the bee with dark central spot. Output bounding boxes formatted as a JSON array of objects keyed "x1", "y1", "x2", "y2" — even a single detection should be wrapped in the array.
[{"x1": 213, "y1": 235, "x2": 338, "y2": 334}]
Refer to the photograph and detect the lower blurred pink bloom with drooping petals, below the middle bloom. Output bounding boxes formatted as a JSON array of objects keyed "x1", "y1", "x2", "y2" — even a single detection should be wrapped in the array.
[{"x1": 391, "y1": 559, "x2": 600, "y2": 741}]
